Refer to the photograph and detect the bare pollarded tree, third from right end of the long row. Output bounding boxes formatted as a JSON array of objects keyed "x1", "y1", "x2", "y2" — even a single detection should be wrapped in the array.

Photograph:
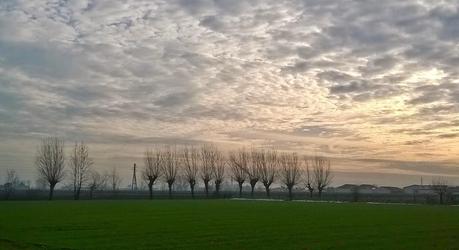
[{"x1": 279, "y1": 153, "x2": 300, "y2": 200}]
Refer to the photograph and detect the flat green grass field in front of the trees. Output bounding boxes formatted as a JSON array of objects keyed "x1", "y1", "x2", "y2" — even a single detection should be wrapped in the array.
[{"x1": 0, "y1": 200, "x2": 459, "y2": 250}]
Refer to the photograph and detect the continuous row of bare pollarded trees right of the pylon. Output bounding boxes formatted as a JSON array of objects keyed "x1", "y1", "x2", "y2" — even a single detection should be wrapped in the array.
[{"x1": 143, "y1": 145, "x2": 332, "y2": 198}]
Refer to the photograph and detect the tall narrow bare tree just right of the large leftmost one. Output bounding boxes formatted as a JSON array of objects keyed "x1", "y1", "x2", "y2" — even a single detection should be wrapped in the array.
[{"x1": 70, "y1": 142, "x2": 93, "y2": 200}]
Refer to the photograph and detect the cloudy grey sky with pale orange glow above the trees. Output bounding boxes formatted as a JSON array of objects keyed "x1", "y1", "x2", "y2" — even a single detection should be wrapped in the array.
[{"x1": 0, "y1": 0, "x2": 459, "y2": 186}]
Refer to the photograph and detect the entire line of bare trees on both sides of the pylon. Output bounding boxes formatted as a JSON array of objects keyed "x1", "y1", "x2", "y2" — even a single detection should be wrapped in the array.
[{"x1": 36, "y1": 137, "x2": 332, "y2": 200}]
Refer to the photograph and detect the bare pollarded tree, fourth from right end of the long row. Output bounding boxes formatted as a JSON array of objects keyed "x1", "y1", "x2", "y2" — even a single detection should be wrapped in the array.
[{"x1": 254, "y1": 150, "x2": 279, "y2": 198}]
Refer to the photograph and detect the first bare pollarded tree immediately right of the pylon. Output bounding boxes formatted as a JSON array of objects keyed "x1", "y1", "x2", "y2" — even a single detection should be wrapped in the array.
[{"x1": 143, "y1": 149, "x2": 163, "y2": 199}]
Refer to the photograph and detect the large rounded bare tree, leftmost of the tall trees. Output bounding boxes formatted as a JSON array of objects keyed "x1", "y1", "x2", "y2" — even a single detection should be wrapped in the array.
[{"x1": 35, "y1": 137, "x2": 65, "y2": 200}]
